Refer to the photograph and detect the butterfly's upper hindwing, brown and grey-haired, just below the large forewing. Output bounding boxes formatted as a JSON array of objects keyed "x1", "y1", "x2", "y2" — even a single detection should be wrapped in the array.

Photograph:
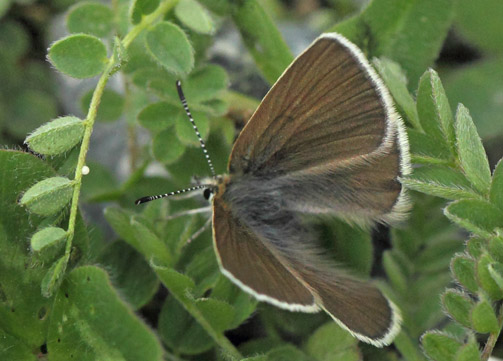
[{"x1": 280, "y1": 131, "x2": 410, "y2": 225}]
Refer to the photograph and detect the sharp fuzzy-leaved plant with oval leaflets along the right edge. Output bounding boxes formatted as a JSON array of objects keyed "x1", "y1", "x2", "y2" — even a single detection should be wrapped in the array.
[{"x1": 378, "y1": 63, "x2": 503, "y2": 361}]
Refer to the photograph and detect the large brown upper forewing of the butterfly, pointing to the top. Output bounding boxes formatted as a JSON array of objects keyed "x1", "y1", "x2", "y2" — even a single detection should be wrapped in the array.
[{"x1": 229, "y1": 35, "x2": 394, "y2": 174}]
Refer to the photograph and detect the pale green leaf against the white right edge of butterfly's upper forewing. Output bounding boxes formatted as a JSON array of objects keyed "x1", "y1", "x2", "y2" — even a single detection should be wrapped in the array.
[{"x1": 373, "y1": 58, "x2": 422, "y2": 130}]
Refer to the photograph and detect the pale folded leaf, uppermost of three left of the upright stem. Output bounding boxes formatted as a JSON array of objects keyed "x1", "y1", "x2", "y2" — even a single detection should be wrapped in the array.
[{"x1": 25, "y1": 116, "x2": 85, "y2": 155}]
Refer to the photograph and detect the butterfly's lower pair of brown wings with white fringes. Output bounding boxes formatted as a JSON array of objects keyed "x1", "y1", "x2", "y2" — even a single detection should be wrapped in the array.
[{"x1": 213, "y1": 191, "x2": 400, "y2": 346}]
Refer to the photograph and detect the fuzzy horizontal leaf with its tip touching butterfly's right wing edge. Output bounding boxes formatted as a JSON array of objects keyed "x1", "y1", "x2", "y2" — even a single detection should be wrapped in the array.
[{"x1": 400, "y1": 165, "x2": 479, "y2": 199}]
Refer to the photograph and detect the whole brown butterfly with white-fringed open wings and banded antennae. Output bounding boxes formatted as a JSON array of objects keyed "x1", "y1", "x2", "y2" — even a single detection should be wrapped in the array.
[{"x1": 137, "y1": 33, "x2": 410, "y2": 347}]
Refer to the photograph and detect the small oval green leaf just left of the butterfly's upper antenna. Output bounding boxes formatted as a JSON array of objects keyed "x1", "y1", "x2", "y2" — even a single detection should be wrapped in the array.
[{"x1": 138, "y1": 102, "x2": 179, "y2": 136}]
